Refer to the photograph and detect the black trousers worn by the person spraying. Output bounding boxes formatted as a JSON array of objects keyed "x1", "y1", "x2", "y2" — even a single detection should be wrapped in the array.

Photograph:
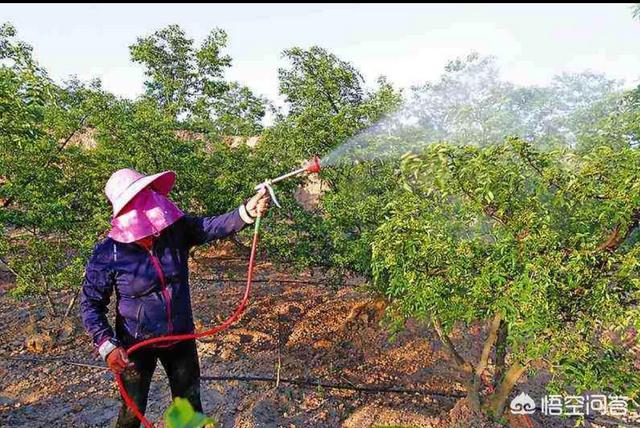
[{"x1": 116, "y1": 340, "x2": 202, "y2": 428}]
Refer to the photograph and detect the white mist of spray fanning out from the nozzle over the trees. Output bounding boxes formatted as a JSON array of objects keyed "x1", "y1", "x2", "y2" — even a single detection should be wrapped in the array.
[{"x1": 321, "y1": 54, "x2": 623, "y2": 166}]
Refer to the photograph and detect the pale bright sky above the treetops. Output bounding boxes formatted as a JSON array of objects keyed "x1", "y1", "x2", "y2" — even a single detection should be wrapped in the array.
[{"x1": 0, "y1": 3, "x2": 640, "y2": 108}]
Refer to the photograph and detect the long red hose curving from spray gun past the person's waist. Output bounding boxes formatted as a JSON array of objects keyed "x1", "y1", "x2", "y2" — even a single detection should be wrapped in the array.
[{"x1": 115, "y1": 217, "x2": 260, "y2": 428}]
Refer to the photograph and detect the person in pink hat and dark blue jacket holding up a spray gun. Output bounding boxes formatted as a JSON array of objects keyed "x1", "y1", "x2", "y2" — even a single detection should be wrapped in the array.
[{"x1": 80, "y1": 169, "x2": 270, "y2": 428}]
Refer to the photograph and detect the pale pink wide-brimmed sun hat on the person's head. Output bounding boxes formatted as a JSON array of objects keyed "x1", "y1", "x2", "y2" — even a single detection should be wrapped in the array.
[{"x1": 104, "y1": 168, "x2": 176, "y2": 217}]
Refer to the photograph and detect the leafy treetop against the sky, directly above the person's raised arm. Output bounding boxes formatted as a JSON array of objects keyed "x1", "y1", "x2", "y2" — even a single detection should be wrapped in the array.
[{"x1": 129, "y1": 25, "x2": 265, "y2": 135}]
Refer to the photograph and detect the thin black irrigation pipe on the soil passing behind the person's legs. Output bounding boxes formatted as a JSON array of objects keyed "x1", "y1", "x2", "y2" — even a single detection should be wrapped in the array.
[{"x1": 5, "y1": 356, "x2": 466, "y2": 398}]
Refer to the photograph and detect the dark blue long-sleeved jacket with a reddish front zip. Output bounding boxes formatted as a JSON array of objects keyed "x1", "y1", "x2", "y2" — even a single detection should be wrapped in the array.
[{"x1": 80, "y1": 206, "x2": 250, "y2": 357}]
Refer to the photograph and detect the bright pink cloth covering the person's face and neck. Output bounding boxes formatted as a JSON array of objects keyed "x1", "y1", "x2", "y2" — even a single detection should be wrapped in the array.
[{"x1": 109, "y1": 187, "x2": 184, "y2": 243}]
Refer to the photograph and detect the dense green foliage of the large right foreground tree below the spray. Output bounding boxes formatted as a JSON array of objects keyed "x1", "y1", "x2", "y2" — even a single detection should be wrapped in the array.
[{"x1": 372, "y1": 139, "x2": 640, "y2": 397}]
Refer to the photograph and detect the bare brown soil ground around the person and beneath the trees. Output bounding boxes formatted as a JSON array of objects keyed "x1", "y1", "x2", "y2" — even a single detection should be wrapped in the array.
[{"x1": 0, "y1": 242, "x2": 620, "y2": 427}]
